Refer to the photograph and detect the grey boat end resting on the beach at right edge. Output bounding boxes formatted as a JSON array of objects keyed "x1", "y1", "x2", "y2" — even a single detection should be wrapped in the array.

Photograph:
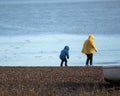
[{"x1": 103, "y1": 66, "x2": 120, "y2": 84}]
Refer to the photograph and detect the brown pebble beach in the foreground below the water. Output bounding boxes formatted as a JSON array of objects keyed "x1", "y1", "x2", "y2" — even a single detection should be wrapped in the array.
[{"x1": 0, "y1": 66, "x2": 120, "y2": 96}]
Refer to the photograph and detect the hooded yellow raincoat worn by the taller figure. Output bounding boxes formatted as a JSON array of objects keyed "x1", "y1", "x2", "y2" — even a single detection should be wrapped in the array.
[{"x1": 82, "y1": 34, "x2": 98, "y2": 54}]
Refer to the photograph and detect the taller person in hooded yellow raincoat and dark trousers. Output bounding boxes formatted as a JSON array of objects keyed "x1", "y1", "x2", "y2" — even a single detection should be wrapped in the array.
[{"x1": 82, "y1": 34, "x2": 98, "y2": 66}]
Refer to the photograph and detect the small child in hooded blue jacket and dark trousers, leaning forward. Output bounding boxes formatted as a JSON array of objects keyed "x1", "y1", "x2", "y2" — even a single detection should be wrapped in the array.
[{"x1": 60, "y1": 46, "x2": 69, "y2": 67}]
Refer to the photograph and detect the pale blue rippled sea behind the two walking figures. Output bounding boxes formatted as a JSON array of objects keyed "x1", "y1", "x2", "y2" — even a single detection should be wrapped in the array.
[{"x1": 0, "y1": 1, "x2": 120, "y2": 66}]
